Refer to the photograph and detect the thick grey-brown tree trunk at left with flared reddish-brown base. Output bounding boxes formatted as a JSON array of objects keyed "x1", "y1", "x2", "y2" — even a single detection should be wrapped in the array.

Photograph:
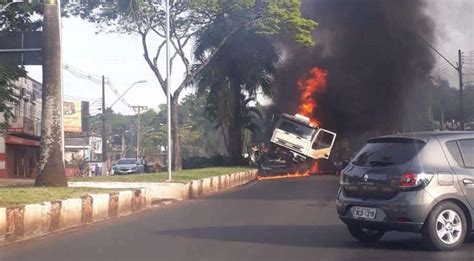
[{"x1": 35, "y1": 0, "x2": 67, "y2": 187}]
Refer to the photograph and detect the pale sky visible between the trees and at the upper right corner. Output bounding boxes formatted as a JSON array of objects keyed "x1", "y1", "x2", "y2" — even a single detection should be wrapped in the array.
[{"x1": 27, "y1": 0, "x2": 474, "y2": 114}]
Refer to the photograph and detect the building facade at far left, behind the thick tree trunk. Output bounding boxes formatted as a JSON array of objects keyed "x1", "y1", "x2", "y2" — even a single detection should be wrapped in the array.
[{"x1": 0, "y1": 77, "x2": 42, "y2": 178}]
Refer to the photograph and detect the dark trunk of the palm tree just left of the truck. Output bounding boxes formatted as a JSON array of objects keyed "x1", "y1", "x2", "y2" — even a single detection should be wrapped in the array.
[{"x1": 229, "y1": 83, "x2": 242, "y2": 165}]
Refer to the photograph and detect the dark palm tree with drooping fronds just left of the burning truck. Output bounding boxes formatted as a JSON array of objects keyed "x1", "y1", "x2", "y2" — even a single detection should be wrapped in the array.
[{"x1": 195, "y1": 23, "x2": 280, "y2": 164}]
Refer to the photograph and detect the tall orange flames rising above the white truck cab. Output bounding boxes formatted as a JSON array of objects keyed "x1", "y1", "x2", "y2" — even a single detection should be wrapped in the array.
[{"x1": 298, "y1": 67, "x2": 328, "y2": 126}]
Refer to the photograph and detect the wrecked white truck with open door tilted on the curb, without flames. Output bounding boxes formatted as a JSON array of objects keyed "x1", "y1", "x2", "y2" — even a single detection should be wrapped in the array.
[{"x1": 258, "y1": 113, "x2": 336, "y2": 175}]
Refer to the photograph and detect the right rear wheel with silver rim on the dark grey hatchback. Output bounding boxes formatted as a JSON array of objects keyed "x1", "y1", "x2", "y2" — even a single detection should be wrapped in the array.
[{"x1": 422, "y1": 201, "x2": 467, "y2": 251}]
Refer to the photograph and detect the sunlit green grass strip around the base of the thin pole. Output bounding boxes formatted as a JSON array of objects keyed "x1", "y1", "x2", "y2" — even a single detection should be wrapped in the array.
[{"x1": 70, "y1": 167, "x2": 251, "y2": 182}]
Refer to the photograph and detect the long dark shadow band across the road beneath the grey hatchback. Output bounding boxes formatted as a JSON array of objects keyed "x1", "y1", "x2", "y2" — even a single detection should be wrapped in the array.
[{"x1": 159, "y1": 225, "x2": 474, "y2": 251}]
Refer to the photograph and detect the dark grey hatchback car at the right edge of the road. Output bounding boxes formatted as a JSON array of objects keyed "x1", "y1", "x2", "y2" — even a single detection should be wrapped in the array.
[{"x1": 337, "y1": 132, "x2": 474, "y2": 250}]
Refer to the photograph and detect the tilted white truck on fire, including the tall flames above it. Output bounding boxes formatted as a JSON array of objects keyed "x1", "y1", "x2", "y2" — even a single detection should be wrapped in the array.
[{"x1": 251, "y1": 67, "x2": 336, "y2": 179}]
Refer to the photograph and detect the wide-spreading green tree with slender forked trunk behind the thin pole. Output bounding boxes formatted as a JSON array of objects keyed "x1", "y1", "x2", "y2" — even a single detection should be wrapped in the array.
[{"x1": 69, "y1": 0, "x2": 316, "y2": 170}]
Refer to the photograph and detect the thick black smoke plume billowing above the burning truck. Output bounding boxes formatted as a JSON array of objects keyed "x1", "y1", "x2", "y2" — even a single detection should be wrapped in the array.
[{"x1": 274, "y1": 0, "x2": 435, "y2": 149}]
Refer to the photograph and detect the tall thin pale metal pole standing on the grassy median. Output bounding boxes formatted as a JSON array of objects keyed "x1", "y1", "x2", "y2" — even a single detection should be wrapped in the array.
[{"x1": 165, "y1": 0, "x2": 173, "y2": 181}]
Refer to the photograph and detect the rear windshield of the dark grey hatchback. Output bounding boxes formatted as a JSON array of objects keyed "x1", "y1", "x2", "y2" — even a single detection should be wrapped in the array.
[{"x1": 352, "y1": 138, "x2": 425, "y2": 167}]
